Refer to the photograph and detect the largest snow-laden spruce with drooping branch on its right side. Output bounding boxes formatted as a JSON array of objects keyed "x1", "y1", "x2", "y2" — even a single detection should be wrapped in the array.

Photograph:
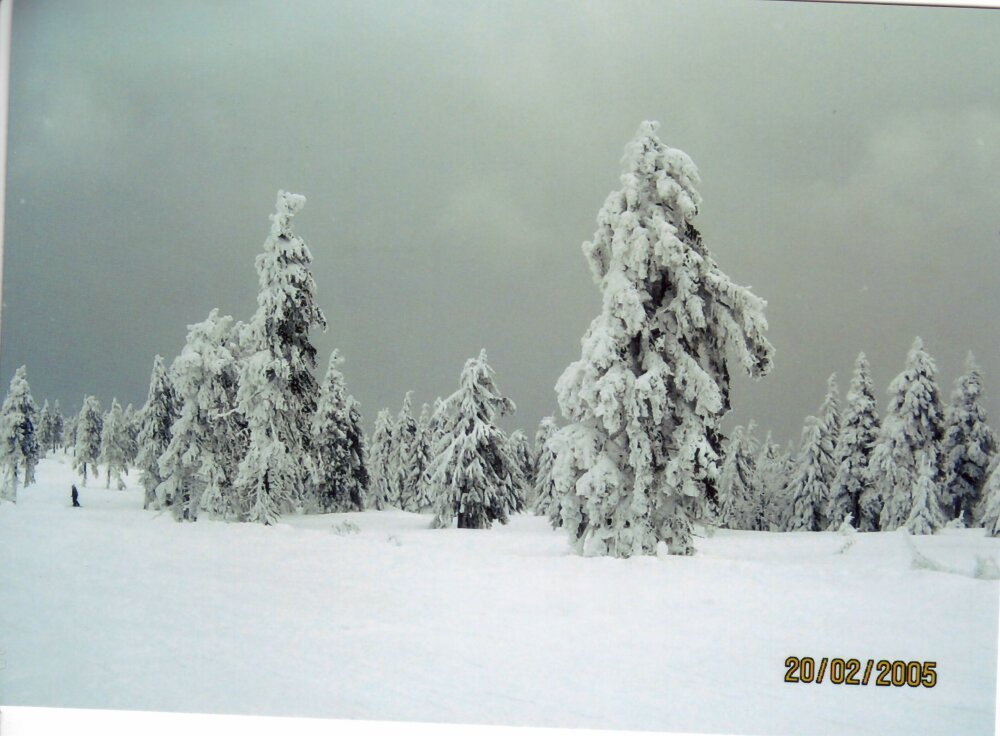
[{"x1": 553, "y1": 122, "x2": 772, "y2": 557}]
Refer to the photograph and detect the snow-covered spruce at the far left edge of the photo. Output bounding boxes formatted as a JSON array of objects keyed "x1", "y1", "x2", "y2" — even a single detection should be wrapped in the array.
[{"x1": 0, "y1": 365, "x2": 39, "y2": 502}]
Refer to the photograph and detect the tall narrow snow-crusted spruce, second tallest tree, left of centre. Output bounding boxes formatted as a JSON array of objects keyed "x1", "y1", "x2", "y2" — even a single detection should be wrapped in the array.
[{"x1": 235, "y1": 191, "x2": 326, "y2": 524}]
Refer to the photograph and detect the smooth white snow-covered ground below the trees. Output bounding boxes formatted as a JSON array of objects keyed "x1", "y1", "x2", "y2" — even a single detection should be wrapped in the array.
[{"x1": 0, "y1": 456, "x2": 1000, "y2": 736}]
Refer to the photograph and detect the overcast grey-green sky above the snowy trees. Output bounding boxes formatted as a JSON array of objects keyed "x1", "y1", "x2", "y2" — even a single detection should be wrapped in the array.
[{"x1": 0, "y1": 0, "x2": 1000, "y2": 442}]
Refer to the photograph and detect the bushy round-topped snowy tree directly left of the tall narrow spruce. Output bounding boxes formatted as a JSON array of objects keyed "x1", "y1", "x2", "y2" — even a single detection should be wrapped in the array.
[{"x1": 156, "y1": 309, "x2": 249, "y2": 521}]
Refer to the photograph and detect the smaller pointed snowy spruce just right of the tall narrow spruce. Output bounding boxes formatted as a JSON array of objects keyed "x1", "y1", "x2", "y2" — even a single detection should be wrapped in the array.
[{"x1": 309, "y1": 350, "x2": 368, "y2": 512}]
